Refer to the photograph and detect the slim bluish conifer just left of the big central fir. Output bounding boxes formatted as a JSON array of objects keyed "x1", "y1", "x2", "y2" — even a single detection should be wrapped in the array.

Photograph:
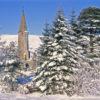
[{"x1": 37, "y1": 22, "x2": 51, "y2": 66}]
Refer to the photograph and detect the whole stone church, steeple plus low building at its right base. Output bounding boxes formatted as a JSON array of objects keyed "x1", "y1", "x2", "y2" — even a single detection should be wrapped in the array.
[{"x1": 18, "y1": 11, "x2": 37, "y2": 69}]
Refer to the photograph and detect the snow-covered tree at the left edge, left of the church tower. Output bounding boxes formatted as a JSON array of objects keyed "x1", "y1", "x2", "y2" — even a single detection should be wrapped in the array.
[{"x1": 0, "y1": 41, "x2": 20, "y2": 92}]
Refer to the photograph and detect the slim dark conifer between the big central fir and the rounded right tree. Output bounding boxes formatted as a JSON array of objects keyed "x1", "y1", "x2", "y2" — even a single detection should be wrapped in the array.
[{"x1": 70, "y1": 10, "x2": 85, "y2": 54}]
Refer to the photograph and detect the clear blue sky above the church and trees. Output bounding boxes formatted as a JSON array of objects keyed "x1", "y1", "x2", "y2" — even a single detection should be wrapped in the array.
[{"x1": 0, "y1": 0, "x2": 100, "y2": 35}]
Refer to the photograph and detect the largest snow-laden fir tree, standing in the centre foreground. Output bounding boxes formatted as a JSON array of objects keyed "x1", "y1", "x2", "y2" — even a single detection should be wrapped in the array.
[{"x1": 33, "y1": 10, "x2": 79, "y2": 95}]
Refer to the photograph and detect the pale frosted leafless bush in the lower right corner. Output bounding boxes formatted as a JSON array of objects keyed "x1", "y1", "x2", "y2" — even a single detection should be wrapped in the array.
[{"x1": 76, "y1": 59, "x2": 100, "y2": 96}]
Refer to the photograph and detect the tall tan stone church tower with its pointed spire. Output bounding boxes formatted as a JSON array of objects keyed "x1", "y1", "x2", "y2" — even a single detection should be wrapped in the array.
[{"x1": 18, "y1": 11, "x2": 29, "y2": 61}]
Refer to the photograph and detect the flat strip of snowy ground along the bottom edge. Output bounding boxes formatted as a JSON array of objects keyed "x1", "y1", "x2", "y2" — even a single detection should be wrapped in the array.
[{"x1": 0, "y1": 93, "x2": 100, "y2": 100}]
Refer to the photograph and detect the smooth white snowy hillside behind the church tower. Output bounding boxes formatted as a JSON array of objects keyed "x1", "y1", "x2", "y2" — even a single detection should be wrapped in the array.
[{"x1": 0, "y1": 35, "x2": 41, "y2": 50}]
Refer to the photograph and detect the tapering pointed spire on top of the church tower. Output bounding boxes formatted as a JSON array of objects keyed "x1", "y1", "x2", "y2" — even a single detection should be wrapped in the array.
[{"x1": 19, "y1": 10, "x2": 27, "y2": 32}]
